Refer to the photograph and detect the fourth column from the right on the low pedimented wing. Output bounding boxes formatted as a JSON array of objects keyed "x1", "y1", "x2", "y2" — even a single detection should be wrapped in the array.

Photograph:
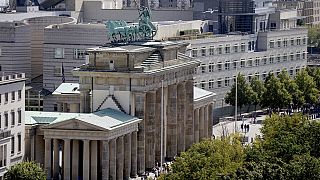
[{"x1": 109, "y1": 139, "x2": 117, "y2": 180}]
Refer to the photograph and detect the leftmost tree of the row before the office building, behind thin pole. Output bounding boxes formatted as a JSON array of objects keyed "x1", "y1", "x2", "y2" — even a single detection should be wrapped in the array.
[{"x1": 225, "y1": 74, "x2": 253, "y2": 114}]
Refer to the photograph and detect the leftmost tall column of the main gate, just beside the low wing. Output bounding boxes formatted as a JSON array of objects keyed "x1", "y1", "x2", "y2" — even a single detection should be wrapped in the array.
[{"x1": 135, "y1": 93, "x2": 146, "y2": 174}]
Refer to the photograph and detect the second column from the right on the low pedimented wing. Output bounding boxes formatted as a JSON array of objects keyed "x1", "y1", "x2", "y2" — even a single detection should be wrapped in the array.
[{"x1": 124, "y1": 134, "x2": 131, "y2": 179}]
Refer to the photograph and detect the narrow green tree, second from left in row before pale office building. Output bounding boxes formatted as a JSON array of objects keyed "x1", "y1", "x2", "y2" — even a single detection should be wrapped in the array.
[{"x1": 250, "y1": 77, "x2": 265, "y2": 111}]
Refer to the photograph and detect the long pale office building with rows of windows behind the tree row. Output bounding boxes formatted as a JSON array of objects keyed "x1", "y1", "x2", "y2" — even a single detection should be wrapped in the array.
[{"x1": 184, "y1": 10, "x2": 308, "y2": 118}]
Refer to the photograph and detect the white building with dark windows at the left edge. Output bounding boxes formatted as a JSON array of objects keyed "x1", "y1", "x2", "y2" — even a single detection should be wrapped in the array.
[{"x1": 0, "y1": 73, "x2": 26, "y2": 179}]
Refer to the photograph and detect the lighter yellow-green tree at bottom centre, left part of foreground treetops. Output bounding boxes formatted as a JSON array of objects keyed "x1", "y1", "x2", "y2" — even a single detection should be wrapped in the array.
[{"x1": 160, "y1": 136, "x2": 244, "y2": 180}]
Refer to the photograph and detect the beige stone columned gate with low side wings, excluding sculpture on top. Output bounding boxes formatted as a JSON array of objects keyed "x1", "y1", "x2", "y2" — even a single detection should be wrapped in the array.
[{"x1": 26, "y1": 42, "x2": 214, "y2": 179}]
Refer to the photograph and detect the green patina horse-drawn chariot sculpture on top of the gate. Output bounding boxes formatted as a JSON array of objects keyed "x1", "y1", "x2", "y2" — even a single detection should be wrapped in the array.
[{"x1": 106, "y1": 7, "x2": 157, "y2": 43}]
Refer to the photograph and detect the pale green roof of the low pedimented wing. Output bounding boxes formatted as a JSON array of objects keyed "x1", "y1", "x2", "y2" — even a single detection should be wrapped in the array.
[{"x1": 25, "y1": 108, "x2": 141, "y2": 130}]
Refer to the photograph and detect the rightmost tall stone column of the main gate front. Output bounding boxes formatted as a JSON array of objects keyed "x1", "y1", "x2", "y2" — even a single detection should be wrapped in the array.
[{"x1": 185, "y1": 79, "x2": 194, "y2": 149}]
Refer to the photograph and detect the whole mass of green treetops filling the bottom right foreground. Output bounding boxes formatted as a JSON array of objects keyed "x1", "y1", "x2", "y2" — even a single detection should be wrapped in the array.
[{"x1": 160, "y1": 114, "x2": 320, "y2": 180}]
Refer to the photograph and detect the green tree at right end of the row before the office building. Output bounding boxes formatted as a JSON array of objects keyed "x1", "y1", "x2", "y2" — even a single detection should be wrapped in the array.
[{"x1": 295, "y1": 70, "x2": 319, "y2": 108}]
